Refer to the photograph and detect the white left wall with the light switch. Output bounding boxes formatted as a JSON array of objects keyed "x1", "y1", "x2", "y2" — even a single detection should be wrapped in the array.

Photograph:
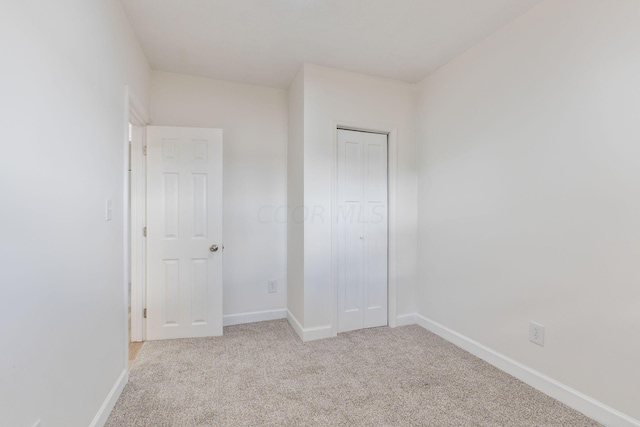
[{"x1": 0, "y1": 0, "x2": 148, "y2": 427}]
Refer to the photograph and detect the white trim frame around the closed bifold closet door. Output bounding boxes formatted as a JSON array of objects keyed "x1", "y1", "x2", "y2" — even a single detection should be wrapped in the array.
[{"x1": 331, "y1": 120, "x2": 398, "y2": 336}]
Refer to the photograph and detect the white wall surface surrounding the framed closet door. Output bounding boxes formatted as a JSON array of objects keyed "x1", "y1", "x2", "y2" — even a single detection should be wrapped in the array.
[{"x1": 304, "y1": 64, "x2": 417, "y2": 329}]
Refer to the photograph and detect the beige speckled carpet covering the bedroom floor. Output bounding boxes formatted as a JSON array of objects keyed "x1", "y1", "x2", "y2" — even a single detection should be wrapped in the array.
[{"x1": 107, "y1": 320, "x2": 599, "y2": 427}]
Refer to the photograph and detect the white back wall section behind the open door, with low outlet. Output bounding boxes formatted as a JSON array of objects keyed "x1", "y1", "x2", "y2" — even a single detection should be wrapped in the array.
[{"x1": 150, "y1": 71, "x2": 288, "y2": 316}]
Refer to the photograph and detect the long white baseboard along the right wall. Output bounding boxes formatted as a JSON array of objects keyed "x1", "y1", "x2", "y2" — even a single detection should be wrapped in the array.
[{"x1": 416, "y1": 314, "x2": 640, "y2": 427}]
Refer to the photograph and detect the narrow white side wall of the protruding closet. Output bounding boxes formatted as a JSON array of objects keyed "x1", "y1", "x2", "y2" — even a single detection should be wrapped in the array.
[{"x1": 287, "y1": 67, "x2": 304, "y2": 322}]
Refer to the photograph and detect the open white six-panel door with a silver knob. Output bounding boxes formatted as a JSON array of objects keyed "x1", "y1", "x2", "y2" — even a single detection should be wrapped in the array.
[{"x1": 147, "y1": 126, "x2": 222, "y2": 340}]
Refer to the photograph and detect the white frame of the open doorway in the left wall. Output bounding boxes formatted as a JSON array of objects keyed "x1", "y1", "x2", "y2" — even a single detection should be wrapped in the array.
[{"x1": 125, "y1": 87, "x2": 149, "y2": 344}]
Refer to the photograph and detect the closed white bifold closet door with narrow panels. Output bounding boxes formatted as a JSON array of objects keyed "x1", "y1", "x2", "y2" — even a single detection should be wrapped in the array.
[{"x1": 337, "y1": 130, "x2": 388, "y2": 332}]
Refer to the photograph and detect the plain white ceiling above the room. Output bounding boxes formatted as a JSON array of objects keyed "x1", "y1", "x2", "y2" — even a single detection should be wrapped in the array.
[{"x1": 121, "y1": 0, "x2": 541, "y2": 88}]
